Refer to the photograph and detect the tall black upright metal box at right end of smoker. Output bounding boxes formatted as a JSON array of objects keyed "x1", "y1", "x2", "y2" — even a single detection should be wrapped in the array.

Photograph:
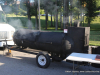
[{"x1": 68, "y1": 27, "x2": 90, "y2": 53}]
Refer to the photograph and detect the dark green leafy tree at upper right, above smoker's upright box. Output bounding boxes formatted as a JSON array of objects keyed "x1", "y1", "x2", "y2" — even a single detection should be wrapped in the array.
[{"x1": 80, "y1": 0, "x2": 98, "y2": 27}]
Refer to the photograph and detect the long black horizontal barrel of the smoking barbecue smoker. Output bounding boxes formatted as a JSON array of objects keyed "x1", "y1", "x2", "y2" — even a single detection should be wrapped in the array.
[{"x1": 14, "y1": 30, "x2": 73, "y2": 53}]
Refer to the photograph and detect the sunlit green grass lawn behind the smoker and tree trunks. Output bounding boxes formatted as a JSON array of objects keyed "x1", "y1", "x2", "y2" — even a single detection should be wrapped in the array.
[{"x1": 7, "y1": 14, "x2": 100, "y2": 46}]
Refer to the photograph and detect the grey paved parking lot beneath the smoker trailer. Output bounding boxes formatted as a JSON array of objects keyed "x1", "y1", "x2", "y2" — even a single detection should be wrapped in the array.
[{"x1": 0, "y1": 50, "x2": 100, "y2": 75}]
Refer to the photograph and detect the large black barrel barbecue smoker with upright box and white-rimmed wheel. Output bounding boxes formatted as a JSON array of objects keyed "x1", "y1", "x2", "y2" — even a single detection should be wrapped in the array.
[{"x1": 13, "y1": 27, "x2": 90, "y2": 68}]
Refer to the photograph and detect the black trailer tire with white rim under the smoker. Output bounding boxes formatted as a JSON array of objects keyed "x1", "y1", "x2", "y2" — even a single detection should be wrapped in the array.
[{"x1": 36, "y1": 52, "x2": 50, "y2": 68}]
